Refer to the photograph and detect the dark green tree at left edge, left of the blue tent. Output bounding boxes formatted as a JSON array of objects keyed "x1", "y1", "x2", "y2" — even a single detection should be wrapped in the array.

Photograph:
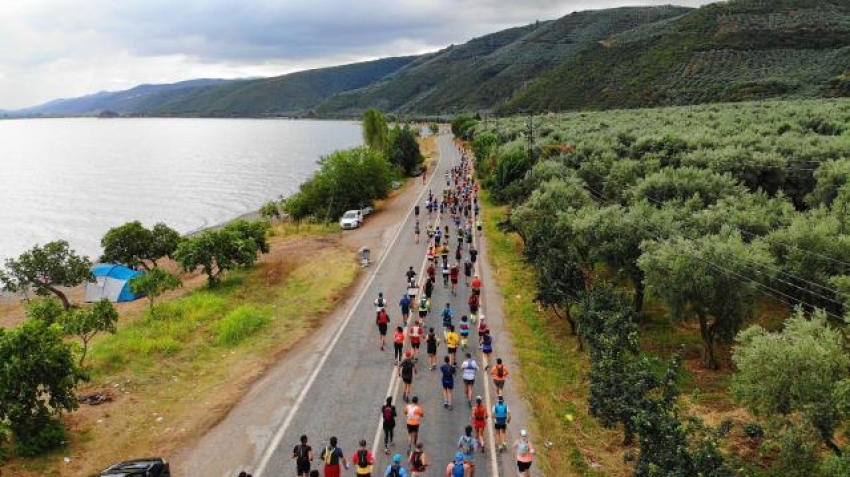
[{"x1": 0, "y1": 240, "x2": 91, "y2": 310}]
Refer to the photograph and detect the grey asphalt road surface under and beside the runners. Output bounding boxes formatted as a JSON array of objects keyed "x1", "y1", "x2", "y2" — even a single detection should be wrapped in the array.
[{"x1": 174, "y1": 135, "x2": 542, "y2": 477}]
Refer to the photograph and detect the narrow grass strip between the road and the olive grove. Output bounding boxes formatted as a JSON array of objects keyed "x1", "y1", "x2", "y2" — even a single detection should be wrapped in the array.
[{"x1": 482, "y1": 193, "x2": 627, "y2": 476}]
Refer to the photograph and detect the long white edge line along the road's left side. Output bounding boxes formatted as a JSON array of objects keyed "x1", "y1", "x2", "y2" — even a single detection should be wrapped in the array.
[{"x1": 254, "y1": 134, "x2": 443, "y2": 477}]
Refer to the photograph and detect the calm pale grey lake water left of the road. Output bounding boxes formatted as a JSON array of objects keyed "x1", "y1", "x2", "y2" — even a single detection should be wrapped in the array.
[{"x1": 0, "y1": 119, "x2": 361, "y2": 259}]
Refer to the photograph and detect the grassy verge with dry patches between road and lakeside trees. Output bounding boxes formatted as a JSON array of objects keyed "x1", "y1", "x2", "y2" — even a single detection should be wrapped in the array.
[{"x1": 3, "y1": 224, "x2": 360, "y2": 476}]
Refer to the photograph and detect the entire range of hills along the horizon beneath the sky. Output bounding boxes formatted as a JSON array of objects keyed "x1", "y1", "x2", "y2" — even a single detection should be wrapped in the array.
[{"x1": 8, "y1": 0, "x2": 850, "y2": 117}]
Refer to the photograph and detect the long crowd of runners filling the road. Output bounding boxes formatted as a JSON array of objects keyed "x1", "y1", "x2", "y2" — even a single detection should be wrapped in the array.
[{"x1": 292, "y1": 146, "x2": 535, "y2": 477}]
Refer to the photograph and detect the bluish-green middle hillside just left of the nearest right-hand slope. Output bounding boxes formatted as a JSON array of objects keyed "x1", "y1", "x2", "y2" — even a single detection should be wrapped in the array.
[{"x1": 319, "y1": 7, "x2": 691, "y2": 114}]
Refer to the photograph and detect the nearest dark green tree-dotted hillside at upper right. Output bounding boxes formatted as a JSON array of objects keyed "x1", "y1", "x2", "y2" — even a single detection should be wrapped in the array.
[{"x1": 500, "y1": 0, "x2": 850, "y2": 112}]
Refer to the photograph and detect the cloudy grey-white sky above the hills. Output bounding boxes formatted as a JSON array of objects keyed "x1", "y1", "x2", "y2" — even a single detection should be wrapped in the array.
[{"x1": 0, "y1": 0, "x2": 711, "y2": 109}]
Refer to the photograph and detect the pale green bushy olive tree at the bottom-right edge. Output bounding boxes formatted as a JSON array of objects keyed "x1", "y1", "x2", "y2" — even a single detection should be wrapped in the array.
[{"x1": 731, "y1": 309, "x2": 850, "y2": 454}]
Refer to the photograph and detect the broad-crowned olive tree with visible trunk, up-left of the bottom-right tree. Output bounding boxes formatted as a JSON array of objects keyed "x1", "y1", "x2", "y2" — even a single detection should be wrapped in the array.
[{"x1": 638, "y1": 231, "x2": 773, "y2": 369}]
